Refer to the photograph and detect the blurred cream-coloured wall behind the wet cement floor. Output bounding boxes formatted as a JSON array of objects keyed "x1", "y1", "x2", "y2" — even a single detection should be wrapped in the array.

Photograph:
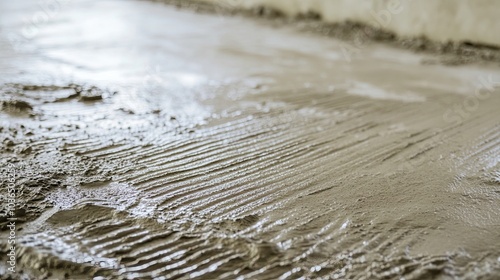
[{"x1": 203, "y1": 0, "x2": 500, "y2": 46}]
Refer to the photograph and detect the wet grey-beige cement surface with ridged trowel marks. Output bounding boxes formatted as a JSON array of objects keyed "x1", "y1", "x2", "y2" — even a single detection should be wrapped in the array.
[{"x1": 0, "y1": 1, "x2": 500, "y2": 279}]
